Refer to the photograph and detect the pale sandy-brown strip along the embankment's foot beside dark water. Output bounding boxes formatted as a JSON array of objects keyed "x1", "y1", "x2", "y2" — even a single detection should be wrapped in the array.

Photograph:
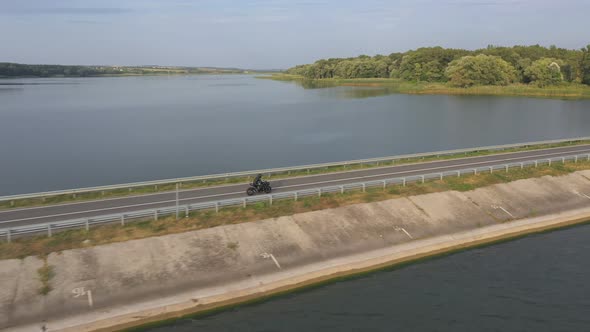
[{"x1": 24, "y1": 208, "x2": 590, "y2": 332}]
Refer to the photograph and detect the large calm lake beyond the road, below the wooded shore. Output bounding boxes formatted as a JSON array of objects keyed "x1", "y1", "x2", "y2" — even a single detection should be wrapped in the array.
[{"x1": 0, "y1": 75, "x2": 590, "y2": 195}]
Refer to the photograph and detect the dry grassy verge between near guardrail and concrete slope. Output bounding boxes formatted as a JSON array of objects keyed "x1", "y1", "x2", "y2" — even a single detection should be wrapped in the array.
[{"x1": 0, "y1": 162, "x2": 590, "y2": 259}]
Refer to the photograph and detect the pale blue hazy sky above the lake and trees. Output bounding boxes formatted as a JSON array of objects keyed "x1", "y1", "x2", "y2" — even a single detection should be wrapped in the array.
[{"x1": 0, "y1": 0, "x2": 590, "y2": 69}]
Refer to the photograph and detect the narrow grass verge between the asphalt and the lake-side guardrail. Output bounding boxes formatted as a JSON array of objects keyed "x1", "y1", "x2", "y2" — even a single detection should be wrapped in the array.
[{"x1": 0, "y1": 141, "x2": 590, "y2": 210}]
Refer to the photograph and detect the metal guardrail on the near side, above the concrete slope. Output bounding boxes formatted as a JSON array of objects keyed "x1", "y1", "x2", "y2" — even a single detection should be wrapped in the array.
[{"x1": 0, "y1": 154, "x2": 590, "y2": 242}]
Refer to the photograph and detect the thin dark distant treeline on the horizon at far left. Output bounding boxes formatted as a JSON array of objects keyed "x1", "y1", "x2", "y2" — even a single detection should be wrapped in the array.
[{"x1": 0, "y1": 62, "x2": 252, "y2": 77}]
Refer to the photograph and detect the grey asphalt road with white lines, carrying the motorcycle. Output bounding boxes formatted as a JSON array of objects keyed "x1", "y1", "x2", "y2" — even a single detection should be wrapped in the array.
[{"x1": 0, "y1": 145, "x2": 590, "y2": 228}]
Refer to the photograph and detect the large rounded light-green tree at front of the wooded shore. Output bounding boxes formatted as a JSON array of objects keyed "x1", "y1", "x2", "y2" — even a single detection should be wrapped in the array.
[{"x1": 445, "y1": 54, "x2": 516, "y2": 87}]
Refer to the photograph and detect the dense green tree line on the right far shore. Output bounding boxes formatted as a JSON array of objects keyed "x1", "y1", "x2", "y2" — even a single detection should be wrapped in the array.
[{"x1": 287, "y1": 45, "x2": 590, "y2": 87}]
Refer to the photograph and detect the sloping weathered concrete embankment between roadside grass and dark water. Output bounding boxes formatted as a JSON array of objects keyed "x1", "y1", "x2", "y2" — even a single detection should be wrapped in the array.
[{"x1": 0, "y1": 171, "x2": 590, "y2": 331}]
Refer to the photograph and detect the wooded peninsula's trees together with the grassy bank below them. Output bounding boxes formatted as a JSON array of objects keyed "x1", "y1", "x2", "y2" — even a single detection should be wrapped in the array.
[{"x1": 280, "y1": 45, "x2": 590, "y2": 98}]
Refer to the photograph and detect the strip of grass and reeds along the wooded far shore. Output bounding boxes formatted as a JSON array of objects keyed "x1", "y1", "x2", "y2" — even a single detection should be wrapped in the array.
[{"x1": 259, "y1": 74, "x2": 590, "y2": 99}]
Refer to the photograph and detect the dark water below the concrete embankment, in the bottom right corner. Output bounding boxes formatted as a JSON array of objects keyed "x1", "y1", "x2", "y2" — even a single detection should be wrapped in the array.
[{"x1": 148, "y1": 225, "x2": 590, "y2": 332}]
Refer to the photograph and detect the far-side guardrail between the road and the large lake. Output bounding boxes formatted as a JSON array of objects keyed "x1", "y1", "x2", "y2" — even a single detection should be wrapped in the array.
[{"x1": 0, "y1": 137, "x2": 590, "y2": 202}]
